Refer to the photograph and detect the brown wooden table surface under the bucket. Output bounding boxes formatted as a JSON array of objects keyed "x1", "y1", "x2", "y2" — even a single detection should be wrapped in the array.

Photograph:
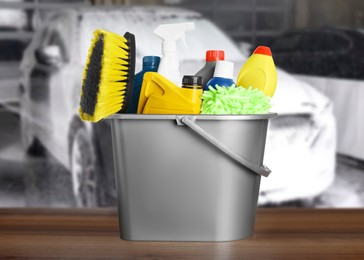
[{"x1": 0, "y1": 208, "x2": 364, "y2": 259}]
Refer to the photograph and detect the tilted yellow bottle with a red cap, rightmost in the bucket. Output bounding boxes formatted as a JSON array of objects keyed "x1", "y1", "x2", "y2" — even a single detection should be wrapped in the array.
[{"x1": 236, "y1": 46, "x2": 277, "y2": 97}]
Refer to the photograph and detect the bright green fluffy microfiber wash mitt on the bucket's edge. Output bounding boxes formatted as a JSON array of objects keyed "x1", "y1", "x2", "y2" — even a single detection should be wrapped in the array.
[{"x1": 201, "y1": 85, "x2": 271, "y2": 115}]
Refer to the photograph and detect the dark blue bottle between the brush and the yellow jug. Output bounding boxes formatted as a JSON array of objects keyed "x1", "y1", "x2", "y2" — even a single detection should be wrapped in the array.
[{"x1": 128, "y1": 56, "x2": 161, "y2": 113}]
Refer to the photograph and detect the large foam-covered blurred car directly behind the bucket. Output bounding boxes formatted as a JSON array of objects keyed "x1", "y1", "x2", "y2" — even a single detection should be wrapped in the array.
[{"x1": 21, "y1": 7, "x2": 335, "y2": 206}]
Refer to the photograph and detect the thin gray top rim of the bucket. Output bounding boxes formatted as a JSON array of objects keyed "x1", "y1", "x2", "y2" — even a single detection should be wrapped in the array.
[{"x1": 106, "y1": 113, "x2": 278, "y2": 120}]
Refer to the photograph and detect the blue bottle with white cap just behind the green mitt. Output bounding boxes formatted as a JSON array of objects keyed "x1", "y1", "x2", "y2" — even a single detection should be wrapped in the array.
[{"x1": 204, "y1": 61, "x2": 235, "y2": 90}]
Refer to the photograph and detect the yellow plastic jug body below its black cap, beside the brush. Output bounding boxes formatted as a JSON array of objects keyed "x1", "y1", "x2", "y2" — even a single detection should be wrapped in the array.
[{"x1": 138, "y1": 72, "x2": 203, "y2": 114}]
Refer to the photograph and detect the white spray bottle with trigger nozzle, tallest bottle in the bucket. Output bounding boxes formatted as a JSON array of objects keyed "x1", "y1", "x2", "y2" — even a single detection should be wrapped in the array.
[{"x1": 153, "y1": 22, "x2": 195, "y2": 86}]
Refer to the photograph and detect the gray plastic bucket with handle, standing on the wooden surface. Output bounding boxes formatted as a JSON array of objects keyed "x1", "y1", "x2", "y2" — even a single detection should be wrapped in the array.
[{"x1": 109, "y1": 114, "x2": 276, "y2": 241}]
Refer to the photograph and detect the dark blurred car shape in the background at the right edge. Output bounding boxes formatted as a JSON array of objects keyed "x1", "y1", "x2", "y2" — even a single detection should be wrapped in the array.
[{"x1": 271, "y1": 28, "x2": 364, "y2": 80}]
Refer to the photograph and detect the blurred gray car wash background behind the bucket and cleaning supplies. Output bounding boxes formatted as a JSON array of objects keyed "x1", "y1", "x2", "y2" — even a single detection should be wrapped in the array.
[{"x1": 0, "y1": 0, "x2": 364, "y2": 207}]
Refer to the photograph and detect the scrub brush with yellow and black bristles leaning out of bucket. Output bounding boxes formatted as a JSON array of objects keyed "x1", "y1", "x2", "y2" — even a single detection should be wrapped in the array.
[{"x1": 79, "y1": 30, "x2": 135, "y2": 122}]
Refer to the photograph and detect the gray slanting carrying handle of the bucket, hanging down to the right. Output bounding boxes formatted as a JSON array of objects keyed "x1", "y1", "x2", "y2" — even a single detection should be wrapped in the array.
[{"x1": 176, "y1": 116, "x2": 271, "y2": 177}]
